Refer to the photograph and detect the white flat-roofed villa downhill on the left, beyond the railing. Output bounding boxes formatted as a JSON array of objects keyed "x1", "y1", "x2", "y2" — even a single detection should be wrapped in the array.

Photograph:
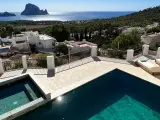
[{"x1": 12, "y1": 31, "x2": 56, "y2": 49}]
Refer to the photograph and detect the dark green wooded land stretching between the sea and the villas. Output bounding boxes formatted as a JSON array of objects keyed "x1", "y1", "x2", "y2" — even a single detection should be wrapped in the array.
[{"x1": 0, "y1": 6, "x2": 160, "y2": 54}]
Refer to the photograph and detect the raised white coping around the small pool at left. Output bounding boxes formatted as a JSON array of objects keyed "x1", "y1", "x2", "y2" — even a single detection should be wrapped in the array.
[{"x1": 0, "y1": 73, "x2": 51, "y2": 120}]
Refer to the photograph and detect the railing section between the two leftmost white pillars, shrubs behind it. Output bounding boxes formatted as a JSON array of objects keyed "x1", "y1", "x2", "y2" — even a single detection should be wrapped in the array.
[{"x1": 3, "y1": 59, "x2": 23, "y2": 71}]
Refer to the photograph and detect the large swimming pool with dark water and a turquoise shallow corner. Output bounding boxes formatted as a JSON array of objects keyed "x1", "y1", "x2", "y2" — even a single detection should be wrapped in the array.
[{"x1": 17, "y1": 69, "x2": 160, "y2": 120}]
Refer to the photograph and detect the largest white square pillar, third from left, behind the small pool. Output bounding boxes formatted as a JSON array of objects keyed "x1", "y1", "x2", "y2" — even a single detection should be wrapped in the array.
[{"x1": 47, "y1": 56, "x2": 55, "y2": 70}]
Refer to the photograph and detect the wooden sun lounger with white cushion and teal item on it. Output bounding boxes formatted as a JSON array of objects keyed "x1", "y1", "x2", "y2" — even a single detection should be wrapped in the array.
[{"x1": 136, "y1": 60, "x2": 160, "y2": 75}]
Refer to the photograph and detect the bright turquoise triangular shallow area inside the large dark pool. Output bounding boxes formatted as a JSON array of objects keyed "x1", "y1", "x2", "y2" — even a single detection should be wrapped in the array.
[{"x1": 89, "y1": 95, "x2": 160, "y2": 120}]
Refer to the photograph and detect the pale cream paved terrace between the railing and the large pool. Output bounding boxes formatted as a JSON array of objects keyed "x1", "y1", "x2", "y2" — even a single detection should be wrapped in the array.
[{"x1": 36, "y1": 58, "x2": 160, "y2": 98}]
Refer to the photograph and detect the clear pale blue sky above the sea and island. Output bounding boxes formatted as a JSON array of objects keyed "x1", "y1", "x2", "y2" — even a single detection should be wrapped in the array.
[{"x1": 0, "y1": 0, "x2": 160, "y2": 12}]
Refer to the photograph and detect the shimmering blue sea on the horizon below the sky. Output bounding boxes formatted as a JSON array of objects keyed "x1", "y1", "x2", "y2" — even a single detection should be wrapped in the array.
[{"x1": 0, "y1": 11, "x2": 134, "y2": 21}]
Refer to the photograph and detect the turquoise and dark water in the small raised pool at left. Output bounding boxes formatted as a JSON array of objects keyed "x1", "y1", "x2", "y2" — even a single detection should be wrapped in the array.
[{"x1": 0, "y1": 77, "x2": 41, "y2": 115}]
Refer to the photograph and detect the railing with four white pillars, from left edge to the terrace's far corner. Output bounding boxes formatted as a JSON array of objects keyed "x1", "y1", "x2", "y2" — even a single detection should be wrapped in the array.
[{"x1": 0, "y1": 46, "x2": 97, "y2": 74}]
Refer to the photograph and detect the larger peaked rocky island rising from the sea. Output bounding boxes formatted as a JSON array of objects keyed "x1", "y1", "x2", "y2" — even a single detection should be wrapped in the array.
[{"x1": 21, "y1": 3, "x2": 48, "y2": 15}]
